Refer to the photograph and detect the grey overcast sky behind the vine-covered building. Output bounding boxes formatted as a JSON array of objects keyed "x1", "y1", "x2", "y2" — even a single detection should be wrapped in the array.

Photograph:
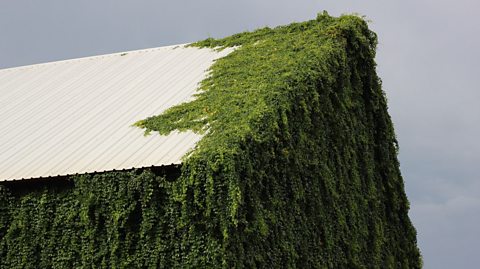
[{"x1": 0, "y1": 0, "x2": 480, "y2": 268}]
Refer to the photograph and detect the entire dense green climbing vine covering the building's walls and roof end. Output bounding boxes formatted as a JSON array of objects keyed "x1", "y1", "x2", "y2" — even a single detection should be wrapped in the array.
[{"x1": 0, "y1": 14, "x2": 421, "y2": 268}]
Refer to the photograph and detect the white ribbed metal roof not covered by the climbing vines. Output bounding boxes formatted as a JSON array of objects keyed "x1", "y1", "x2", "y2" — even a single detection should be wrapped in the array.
[{"x1": 0, "y1": 45, "x2": 231, "y2": 181}]
